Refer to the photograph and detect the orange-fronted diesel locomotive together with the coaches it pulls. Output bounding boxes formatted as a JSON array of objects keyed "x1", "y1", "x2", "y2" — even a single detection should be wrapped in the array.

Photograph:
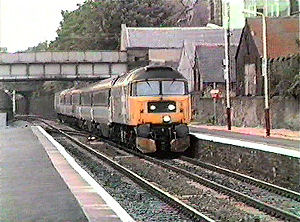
[{"x1": 55, "y1": 66, "x2": 191, "y2": 153}]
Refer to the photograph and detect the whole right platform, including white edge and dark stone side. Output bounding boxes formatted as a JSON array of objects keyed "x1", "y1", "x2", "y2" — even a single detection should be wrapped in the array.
[{"x1": 190, "y1": 125, "x2": 300, "y2": 192}]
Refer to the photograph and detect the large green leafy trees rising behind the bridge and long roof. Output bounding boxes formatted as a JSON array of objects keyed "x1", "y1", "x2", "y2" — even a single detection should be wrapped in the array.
[{"x1": 50, "y1": 0, "x2": 175, "y2": 50}]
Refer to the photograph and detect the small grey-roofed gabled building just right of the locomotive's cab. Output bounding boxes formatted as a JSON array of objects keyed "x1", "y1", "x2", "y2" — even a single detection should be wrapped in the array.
[{"x1": 177, "y1": 29, "x2": 242, "y2": 92}]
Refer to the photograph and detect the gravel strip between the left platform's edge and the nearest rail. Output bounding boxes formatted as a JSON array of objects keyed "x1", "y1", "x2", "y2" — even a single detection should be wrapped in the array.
[{"x1": 51, "y1": 134, "x2": 191, "y2": 222}]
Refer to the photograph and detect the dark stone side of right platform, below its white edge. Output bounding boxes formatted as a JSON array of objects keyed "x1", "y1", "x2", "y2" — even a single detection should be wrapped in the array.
[{"x1": 190, "y1": 137, "x2": 300, "y2": 192}]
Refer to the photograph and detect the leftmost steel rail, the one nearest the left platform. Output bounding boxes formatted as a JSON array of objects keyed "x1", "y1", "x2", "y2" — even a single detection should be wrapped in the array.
[{"x1": 41, "y1": 120, "x2": 214, "y2": 222}]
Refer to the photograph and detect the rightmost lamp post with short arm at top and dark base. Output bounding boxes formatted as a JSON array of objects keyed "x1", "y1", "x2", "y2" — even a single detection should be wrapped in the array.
[{"x1": 243, "y1": 10, "x2": 271, "y2": 136}]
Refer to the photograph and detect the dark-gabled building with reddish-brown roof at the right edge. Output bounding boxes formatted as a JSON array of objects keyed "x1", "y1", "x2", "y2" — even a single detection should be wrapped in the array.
[{"x1": 236, "y1": 17, "x2": 300, "y2": 95}]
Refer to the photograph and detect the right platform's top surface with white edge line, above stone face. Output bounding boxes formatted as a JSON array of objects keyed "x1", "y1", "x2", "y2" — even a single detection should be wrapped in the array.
[{"x1": 189, "y1": 125, "x2": 300, "y2": 158}]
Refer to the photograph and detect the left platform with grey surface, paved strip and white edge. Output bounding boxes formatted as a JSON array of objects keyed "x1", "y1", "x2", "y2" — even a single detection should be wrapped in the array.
[{"x1": 0, "y1": 123, "x2": 133, "y2": 222}]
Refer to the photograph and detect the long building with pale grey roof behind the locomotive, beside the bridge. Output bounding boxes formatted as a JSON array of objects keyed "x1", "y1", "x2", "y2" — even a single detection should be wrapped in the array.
[{"x1": 121, "y1": 25, "x2": 241, "y2": 91}]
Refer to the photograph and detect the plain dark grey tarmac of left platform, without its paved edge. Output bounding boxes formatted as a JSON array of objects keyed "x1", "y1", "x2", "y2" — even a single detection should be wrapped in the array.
[{"x1": 0, "y1": 127, "x2": 88, "y2": 222}]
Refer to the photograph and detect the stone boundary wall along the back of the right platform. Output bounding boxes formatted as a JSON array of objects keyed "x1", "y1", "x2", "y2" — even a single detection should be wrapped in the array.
[{"x1": 192, "y1": 95, "x2": 300, "y2": 130}]
